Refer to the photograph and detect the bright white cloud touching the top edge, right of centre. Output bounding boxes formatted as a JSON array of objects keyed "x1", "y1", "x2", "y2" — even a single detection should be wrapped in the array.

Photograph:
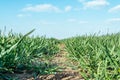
[{"x1": 83, "y1": 0, "x2": 109, "y2": 9}]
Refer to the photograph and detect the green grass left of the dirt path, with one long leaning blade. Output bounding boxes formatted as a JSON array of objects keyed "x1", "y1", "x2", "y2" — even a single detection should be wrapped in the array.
[{"x1": 0, "y1": 30, "x2": 59, "y2": 78}]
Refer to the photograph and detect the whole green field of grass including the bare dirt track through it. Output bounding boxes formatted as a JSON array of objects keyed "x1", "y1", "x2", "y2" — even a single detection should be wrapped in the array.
[{"x1": 0, "y1": 30, "x2": 120, "y2": 80}]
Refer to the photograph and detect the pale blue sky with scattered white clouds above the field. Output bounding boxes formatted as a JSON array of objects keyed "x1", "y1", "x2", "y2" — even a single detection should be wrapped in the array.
[{"x1": 0, "y1": 0, "x2": 120, "y2": 39}]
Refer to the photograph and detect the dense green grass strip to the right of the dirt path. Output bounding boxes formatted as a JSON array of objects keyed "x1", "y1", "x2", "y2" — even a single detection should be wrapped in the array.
[{"x1": 63, "y1": 33, "x2": 120, "y2": 80}]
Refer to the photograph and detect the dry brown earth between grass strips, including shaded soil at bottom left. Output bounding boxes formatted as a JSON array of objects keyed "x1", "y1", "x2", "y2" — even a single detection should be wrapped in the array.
[{"x1": 2, "y1": 44, "x2": 84, "y2": 80}]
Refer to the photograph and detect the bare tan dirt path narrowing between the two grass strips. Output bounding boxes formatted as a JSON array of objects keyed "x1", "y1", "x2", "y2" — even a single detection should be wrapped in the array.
[{"x1": 38, "y1": 44, "x2": 84, "y2": 80}]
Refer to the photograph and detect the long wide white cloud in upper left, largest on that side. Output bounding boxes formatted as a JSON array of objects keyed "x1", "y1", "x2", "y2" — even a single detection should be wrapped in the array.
[{"x1": 22, "y1": 4, "x2": 60, "y2": 12}]
